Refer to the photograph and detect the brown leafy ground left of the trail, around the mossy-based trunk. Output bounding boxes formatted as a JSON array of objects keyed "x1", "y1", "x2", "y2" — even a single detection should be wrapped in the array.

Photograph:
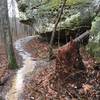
[{"x1": 0, "y1": 43, "x2": 15, "y2": 100}]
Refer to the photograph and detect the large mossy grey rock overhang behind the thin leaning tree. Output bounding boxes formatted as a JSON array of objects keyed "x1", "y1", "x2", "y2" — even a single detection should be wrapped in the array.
[{"x1": 18, "y1": 0, "x2": 94, "y2": 32}]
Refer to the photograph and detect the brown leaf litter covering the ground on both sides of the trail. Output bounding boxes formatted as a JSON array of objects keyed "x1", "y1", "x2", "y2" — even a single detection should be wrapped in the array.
[{"x1": 0, "y1": 40, "x2": 100, "y2": 100}]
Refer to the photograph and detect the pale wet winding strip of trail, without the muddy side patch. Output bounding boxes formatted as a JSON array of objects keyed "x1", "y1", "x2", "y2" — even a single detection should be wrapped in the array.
[{"x1": 5, "y1": 36, "x2": 36, "y2": 100}]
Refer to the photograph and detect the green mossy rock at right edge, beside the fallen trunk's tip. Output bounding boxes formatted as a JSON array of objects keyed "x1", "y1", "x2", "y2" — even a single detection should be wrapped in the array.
[{"x1": 87, "y1": 16, "x2": 100, "y2": 62}]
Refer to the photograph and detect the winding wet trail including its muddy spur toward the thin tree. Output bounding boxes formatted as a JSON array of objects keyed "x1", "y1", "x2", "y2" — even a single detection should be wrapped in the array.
[{"x1": 5, "y1": 36, "x2": 48, "y2": 100}]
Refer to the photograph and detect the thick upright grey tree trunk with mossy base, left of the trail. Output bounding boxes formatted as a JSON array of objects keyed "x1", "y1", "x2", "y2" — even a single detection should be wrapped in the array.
[{"x1": 0, "y1": 0, "x2": 18, "y2": 69}]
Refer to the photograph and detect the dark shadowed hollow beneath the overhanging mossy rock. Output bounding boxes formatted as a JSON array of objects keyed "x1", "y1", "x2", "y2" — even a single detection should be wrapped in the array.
[{"x1": 40, "y1": 26, "x2": 91, "y2": 44}]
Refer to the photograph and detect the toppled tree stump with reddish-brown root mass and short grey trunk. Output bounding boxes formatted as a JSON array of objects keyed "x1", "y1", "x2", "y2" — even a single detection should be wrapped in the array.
[{"x1": 54, "y1": 31, "x2": 90, "y2": 69}]
